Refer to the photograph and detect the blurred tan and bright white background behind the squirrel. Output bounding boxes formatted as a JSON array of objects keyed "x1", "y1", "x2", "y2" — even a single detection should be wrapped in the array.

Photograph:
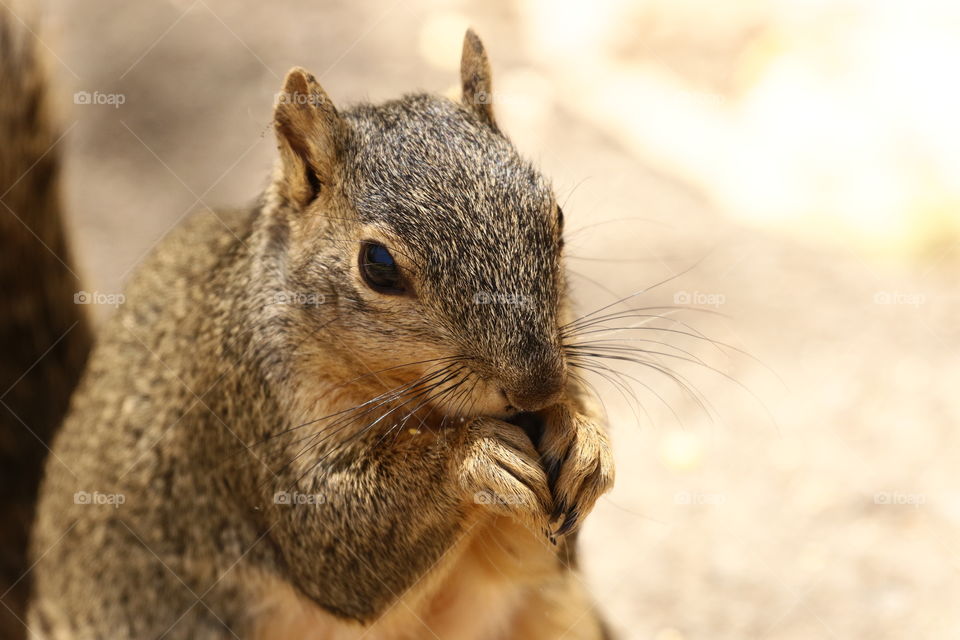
[{"x1": 33, "y1": 0, "x2": 960, "y2": 640}]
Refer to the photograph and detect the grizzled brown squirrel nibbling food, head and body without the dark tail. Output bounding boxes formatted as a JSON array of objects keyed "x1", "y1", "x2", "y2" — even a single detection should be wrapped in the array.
[{"x1": 2, "y1": 8, "x2": 614, "y2": 640}]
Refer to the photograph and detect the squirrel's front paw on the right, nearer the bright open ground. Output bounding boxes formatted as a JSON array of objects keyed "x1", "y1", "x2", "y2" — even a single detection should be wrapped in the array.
[{"x1": 540, "y1": 404, "x2": 614, "y2": 535}]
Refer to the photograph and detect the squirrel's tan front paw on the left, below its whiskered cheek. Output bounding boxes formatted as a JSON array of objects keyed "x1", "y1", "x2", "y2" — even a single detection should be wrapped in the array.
[{"x1": 456, "y1": 417, "x2": 553, "y2": 536}]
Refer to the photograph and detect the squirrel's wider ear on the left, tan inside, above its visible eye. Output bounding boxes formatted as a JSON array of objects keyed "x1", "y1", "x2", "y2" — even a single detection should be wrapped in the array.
[{"x1": 273, "y1": 67, "x2": 344, "y2": 206}]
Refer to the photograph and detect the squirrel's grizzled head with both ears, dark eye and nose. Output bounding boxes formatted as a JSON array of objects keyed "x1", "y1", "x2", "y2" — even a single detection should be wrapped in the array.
[{"x1": 273, "y1": 31, "x2": 567, "y2": 416}]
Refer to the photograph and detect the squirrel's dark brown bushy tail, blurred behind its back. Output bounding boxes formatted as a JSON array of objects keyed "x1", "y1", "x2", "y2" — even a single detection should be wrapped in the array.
[{"x1": 0, "y1": 3, "x2": 91, "y2": 638}]
